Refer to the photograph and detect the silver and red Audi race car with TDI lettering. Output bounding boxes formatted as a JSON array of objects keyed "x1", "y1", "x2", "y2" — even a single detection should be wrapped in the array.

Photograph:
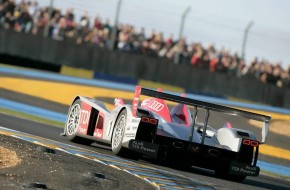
[{"x1": 63, "y1": 86, "x2": 271, "y2": 181}]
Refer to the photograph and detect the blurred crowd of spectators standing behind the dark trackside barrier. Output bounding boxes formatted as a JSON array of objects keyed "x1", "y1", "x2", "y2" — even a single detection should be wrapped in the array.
[{"x1": 0, "y1": 0, "x2": 290, "y2": 87}]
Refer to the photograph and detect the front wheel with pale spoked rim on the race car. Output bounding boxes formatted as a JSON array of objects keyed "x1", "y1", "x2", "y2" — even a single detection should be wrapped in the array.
[{"x1": 64, "y1": 99, "x2": 93, "y2": 145}]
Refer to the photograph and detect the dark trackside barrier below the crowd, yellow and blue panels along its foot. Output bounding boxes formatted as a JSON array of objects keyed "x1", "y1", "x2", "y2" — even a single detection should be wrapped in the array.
[{"x1": 0, "y1": 30, "x2": 290, "y2": 108}]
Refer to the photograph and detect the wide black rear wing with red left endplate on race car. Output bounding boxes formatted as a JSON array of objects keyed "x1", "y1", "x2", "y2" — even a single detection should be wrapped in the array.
[{"x1": 132, "y1": 86, "x2": 271, "y2": 144}]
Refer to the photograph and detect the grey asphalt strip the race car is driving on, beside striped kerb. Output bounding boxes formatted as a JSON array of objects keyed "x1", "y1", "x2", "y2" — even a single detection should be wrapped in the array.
[{"x1": 0, "y1": 114, "x2": 290, "y2": 190}]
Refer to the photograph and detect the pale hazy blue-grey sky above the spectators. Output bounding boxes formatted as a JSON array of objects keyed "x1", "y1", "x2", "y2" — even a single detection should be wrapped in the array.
[{"x1": 28, "y1": 0, "x2": 290, "y2": 67}]
